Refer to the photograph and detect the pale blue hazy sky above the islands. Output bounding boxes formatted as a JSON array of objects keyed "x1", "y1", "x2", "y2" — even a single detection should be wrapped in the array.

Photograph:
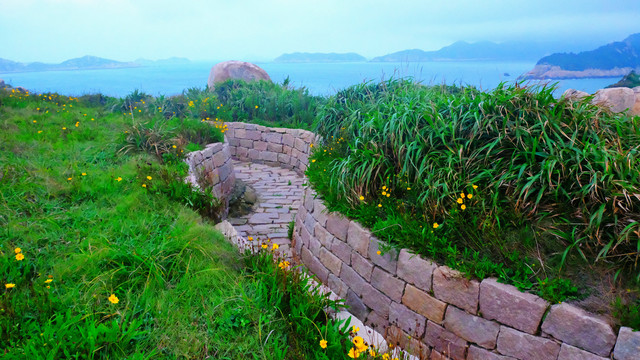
[{"x1": 0, "y1": 0, "x2": 640, "y2": 63}]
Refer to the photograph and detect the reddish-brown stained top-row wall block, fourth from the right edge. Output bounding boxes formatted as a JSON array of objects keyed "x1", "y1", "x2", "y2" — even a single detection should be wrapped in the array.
[{"x1": 433, "y1": 266, "x2": 480, "y2": 314}]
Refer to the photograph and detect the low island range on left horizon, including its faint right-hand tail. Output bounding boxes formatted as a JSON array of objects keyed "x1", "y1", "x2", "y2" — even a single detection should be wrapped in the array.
[{"x1": 0, "y1": 55, "x2": 190, "y2": 73}]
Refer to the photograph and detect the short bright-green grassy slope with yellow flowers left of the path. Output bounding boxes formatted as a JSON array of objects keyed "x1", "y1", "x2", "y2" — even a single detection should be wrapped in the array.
[{"x1": 0, "y1": 90, "x2": 404, "y2": 359}]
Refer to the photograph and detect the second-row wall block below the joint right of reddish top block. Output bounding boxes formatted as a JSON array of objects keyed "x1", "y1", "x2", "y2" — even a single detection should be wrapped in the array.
[{"x1": 444, "y1": 306, "x2": 500, "y2": 349}]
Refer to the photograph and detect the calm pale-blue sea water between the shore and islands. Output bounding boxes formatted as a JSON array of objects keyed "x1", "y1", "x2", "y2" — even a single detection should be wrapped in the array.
[{"x1": 0, "y1": 62, "x2": 618, "y2": 97}]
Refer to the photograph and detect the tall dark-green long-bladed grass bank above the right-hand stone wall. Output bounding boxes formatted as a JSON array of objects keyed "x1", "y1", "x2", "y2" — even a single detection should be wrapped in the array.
[{"x1": 307, "y1": 80, "x2": 640, "y2": 324}]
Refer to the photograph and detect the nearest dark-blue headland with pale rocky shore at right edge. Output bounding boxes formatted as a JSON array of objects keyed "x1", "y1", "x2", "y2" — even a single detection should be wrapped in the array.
[{"x1": 523, "y1": 33, "x2": 640, "y2": 80}]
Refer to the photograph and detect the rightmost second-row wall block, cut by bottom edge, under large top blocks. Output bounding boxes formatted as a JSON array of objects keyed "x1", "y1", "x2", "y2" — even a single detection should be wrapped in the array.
[{"x1": 498, "y1": 326, "x2": 560, "y2": 360}]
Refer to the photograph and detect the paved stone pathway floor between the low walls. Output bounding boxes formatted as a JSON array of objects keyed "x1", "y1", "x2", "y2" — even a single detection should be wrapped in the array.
[{"x1": 228, "y1": 160, "x2": 305, "y2": 258}]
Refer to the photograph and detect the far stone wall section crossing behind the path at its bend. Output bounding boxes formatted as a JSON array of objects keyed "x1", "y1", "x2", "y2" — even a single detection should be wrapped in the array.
[{"x1": 225, "y1": 122, "x2": 319, "y2": 175}]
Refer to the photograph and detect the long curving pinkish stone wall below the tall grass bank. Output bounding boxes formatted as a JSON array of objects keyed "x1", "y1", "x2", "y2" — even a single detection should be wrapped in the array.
[{"x1": 293, "y1": 188, "x2": 640, "y2": 360}]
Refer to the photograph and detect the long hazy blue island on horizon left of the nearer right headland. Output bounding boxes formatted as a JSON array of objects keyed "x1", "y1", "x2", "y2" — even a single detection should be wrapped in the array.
[{"x1": 371, "y1": 41, "x2": 580, "y2": 62}]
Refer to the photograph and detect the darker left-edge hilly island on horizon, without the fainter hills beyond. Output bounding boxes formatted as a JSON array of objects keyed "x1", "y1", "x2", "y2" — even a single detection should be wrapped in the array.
[{"x1": 0, "y1": 56, "x2": 139, "y2": 73}]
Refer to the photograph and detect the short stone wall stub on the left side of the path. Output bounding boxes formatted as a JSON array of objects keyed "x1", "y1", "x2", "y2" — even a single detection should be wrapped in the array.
[{"x1": 185, "y1": 141, "x2": 236, "y2": 218}]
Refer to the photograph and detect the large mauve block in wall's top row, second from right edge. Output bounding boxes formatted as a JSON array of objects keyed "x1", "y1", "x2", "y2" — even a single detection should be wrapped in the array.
[{"x1": 542, "y1": 303, "x2": 616, "y2": 356}]
